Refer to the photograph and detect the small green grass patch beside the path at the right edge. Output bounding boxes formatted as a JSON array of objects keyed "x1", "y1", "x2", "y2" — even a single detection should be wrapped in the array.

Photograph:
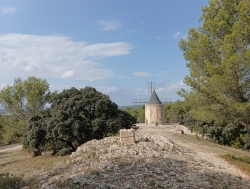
[{"x1": 221, "y1": 154, "x2": 250, "y2": 176}]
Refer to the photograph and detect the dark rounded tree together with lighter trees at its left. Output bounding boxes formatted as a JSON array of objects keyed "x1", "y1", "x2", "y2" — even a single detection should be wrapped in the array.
[{"x1": 0, "y1": 76, "x2": 136, "y2": 156}]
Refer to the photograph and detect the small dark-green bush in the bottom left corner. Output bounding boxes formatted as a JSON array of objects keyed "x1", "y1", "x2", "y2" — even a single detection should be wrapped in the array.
[{"x1": 0, "y1": 173, "x2": 24, "y2": 189}]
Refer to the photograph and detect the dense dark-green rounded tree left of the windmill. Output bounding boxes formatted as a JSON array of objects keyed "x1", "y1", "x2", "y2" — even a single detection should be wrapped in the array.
[{"x1": 24, "y1": 87, "x2": 136, "y2": 156}]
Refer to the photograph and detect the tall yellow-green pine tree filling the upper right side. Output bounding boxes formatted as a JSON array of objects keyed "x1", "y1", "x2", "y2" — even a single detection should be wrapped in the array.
[{"x1": 179, "y1": 0, "x2": 250, "y2": 132}]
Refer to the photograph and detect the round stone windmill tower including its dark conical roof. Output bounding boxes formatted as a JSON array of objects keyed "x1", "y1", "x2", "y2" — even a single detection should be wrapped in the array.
[{"x1": 145, "y1": 90, "x2": 164, "y2": 125}]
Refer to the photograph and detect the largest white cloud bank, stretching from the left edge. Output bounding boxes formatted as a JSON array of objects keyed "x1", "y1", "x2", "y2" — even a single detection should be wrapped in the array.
[{"x1": 0, "y1": 34, "x2": 132, "y2": 80}]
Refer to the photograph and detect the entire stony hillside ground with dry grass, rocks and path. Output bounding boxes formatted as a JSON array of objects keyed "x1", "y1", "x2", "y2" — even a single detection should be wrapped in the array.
[{"x1": 0, "y1": 124, "x2": 250, "y2": 189}]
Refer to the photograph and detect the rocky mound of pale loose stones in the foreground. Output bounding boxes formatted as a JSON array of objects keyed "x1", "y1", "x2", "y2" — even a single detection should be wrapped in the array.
[{"x1": 21, "y1": 126, "x2": 250, "y2": 189}]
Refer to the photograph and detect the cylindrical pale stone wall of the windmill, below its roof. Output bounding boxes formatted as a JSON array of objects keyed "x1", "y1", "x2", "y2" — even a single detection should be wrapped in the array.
[{"x1": 145, "y1": 104, "x2": 164, "y2": 125}]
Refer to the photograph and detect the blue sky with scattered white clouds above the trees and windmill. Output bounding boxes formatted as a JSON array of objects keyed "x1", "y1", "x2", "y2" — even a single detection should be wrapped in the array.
[{"x1": 0, "y1": 0, "x2": 208, "y2": 106}]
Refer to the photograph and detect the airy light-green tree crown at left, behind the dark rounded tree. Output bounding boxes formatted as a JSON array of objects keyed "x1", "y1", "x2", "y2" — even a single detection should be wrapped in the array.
[{"x1": 0, "y1": 76, "x2": 51, "y2": 126}]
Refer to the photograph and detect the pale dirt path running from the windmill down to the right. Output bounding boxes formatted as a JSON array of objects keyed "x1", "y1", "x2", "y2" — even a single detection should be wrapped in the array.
[{"x1": 137, "y1": 124, "x2": 250, "y2": 180}]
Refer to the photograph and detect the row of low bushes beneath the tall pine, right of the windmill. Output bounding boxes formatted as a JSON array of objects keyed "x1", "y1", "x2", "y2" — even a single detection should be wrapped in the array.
[{"x1": 165, "y1": 98, "x2": 250, "y2": 150}]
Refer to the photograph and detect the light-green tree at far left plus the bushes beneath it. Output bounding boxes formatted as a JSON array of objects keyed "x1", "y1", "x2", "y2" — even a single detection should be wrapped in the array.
[{"x1": 0, "y1": 76, "x2": 52, "y2": 143}]
